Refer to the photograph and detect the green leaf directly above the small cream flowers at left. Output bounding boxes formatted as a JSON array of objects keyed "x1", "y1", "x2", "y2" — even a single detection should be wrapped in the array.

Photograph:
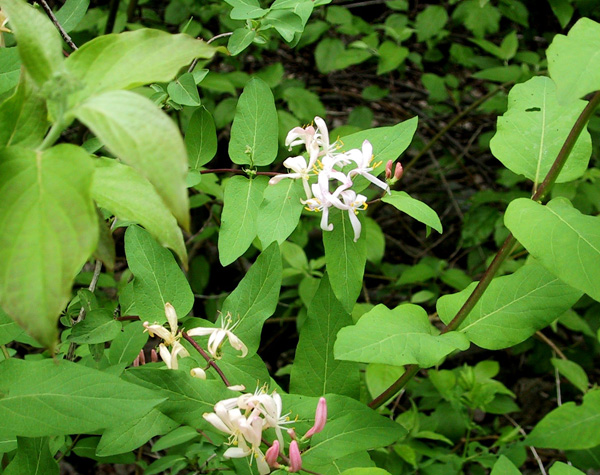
[{"x1": 125, "y1": 226, "x2": 194, "y2": 323}]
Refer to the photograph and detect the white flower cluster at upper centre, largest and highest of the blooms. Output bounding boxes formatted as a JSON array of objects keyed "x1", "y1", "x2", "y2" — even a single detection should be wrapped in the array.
[{"x1": 269, "y1": 117, "x2": 390, "y2": 241}]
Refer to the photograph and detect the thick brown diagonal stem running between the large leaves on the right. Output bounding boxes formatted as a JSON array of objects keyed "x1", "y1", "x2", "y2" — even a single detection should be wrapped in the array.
[{"x1": 369, "y1": 92, "x2": 600, "y2": 409}]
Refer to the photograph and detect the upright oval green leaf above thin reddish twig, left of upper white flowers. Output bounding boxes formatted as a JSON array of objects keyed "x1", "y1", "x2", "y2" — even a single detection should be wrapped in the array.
[{"x1": 229, "y1": 77, "x2": 278, "y2": 166}]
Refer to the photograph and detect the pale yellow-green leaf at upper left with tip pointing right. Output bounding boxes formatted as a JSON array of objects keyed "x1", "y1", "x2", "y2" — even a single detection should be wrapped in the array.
[{"x1": 63, "y1": 25, "x2": 216, "y2": 103}]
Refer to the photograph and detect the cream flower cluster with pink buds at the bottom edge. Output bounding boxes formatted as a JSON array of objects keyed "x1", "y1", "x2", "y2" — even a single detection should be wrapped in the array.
[{"x1": 203, "y1": 387, "x2": 327, "y2": 475}]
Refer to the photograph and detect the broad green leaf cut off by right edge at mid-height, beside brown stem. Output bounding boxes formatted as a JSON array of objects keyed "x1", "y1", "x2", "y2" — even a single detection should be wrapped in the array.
[{"x1": 504, "y1": 198, "x2": 600, "y2": 301}]
